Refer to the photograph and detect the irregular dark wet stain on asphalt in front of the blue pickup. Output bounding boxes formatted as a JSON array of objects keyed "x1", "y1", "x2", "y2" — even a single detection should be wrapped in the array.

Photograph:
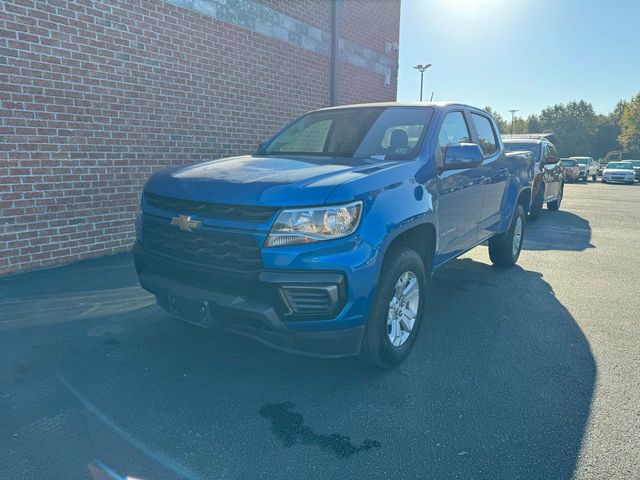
[{"x1": 260, "y1": 402, "x2": 380, "y2": 458}]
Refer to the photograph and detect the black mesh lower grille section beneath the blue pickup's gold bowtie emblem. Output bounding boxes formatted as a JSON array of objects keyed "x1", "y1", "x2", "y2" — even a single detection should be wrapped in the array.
[{"x1": 142, "y1": 219, "x2": 262, "y2": 272}]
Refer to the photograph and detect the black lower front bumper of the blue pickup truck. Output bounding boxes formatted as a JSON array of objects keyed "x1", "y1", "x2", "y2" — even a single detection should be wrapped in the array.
[{"x1": 134, "y1": 243, "x2": 364, "y2": 357}]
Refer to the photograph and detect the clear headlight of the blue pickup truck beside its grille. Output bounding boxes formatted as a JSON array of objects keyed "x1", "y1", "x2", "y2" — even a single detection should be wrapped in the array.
[{"x1": 265, "y1": 202, "x2": 362, "y2": 247}]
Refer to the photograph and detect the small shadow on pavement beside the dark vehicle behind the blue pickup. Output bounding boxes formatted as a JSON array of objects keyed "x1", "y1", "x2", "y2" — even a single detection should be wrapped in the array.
[{"x1": 522, "y1": 210, "x2": 595, "y2": 252}]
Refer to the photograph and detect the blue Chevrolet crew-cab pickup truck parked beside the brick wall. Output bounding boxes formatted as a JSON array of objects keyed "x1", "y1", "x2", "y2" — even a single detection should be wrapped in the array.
[{"x1": 134, "y1": 103, "x2": 533, "y2": 366}]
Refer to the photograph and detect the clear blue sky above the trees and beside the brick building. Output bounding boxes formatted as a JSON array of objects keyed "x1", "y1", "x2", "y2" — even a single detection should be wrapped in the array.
[{"x1": 398, "y1": 0, "x2": 640, "y2": 118}]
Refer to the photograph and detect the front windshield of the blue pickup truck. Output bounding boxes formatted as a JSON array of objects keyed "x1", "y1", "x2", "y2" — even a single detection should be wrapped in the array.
[{"x1": 258, "y1": 107, "x2": 433, "y2": 160}]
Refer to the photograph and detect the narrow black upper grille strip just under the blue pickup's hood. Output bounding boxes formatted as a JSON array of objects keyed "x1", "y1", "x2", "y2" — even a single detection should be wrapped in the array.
[{"x1": 144, "y1": 193, "x2": 277, "y2": 223}]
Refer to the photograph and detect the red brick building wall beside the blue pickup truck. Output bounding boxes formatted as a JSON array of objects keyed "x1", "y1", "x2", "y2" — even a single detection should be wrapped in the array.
[{"x1": 0, "y1": 0, "x2": 400, "y2": 274}]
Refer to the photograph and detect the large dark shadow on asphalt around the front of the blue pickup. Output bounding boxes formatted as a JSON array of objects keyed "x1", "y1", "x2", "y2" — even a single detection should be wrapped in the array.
[{"x1": 0, "y1": 253, "x2": 596, "y2": 479}]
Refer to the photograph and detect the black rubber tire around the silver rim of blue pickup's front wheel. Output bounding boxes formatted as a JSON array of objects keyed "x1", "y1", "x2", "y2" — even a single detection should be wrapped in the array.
[{"x1": 360, "y1": 247, "x2": 429, "y2": 368}]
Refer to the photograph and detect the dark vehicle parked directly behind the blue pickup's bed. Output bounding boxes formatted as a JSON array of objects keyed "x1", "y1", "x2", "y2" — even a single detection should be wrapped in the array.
[{"x1": 503, "y1": 138, "x2": 564, "y2": 220}]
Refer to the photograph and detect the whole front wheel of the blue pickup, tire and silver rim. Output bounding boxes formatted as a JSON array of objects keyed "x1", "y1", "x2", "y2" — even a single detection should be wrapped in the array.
[{"x1": 360, "y1": 247, "x2": 428, "y2": 367}]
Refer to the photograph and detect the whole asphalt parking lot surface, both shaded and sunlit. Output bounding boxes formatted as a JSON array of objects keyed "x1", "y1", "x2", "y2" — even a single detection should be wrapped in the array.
[{"x1": 0, "y1": 183, "x2": 640, "y2": 479}]
